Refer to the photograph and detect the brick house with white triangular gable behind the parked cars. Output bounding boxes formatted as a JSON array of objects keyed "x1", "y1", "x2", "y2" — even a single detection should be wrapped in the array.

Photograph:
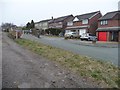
[{"x1": 65, "y1": 11, "x2": 102, "y2": 36}]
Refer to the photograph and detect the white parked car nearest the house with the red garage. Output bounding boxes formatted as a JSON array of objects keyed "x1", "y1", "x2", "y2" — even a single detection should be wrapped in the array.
[{"x1": 80, "y1": 33, "x2": 97, "y2": 41}]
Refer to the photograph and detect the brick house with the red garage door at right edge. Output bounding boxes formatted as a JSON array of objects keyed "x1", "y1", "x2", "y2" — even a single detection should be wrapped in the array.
[{"x1": 97, "y1": 11, "x2": 120, "y2": 41}]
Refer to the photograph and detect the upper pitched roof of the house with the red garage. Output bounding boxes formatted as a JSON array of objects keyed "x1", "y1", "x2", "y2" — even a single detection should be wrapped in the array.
[{"x1": 99, "y1": 10, "x2": 120, "y2": 20}]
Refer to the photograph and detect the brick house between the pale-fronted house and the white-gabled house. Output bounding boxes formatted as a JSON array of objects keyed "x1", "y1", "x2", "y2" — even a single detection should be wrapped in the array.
[{"x1": 49, "y1": 15, "x2": 74, "y2": 30}]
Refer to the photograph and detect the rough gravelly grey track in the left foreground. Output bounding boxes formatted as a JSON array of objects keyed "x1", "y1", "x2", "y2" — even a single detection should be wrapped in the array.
[{"x1": 2, "y1": 33, "x2": 101, "y2": 88}]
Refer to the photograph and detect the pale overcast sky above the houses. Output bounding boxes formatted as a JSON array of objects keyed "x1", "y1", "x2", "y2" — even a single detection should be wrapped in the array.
[{"x1": 0, "y1": 0, "x2": 120, "y2": 26}]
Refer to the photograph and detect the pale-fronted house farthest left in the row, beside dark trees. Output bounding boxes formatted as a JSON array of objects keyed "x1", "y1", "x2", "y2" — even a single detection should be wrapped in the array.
[{"x1": 35, "y1": 19, "x2": 51, "y2": 31}]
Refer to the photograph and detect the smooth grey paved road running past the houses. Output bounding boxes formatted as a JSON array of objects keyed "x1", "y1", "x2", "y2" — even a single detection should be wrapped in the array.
[{"x1": 23, "y1": 35, "x2": 118, "y2": 66}]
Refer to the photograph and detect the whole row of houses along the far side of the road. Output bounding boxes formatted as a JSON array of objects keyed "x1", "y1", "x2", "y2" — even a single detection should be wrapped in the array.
[{"x1": 35, "y1": 10, "x2": 120, "y2": 42}]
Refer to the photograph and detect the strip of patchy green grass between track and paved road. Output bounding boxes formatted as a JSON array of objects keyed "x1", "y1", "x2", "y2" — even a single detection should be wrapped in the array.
[{"x1": 16, "y1": 39, "x2": 120, "y2": 88}]
